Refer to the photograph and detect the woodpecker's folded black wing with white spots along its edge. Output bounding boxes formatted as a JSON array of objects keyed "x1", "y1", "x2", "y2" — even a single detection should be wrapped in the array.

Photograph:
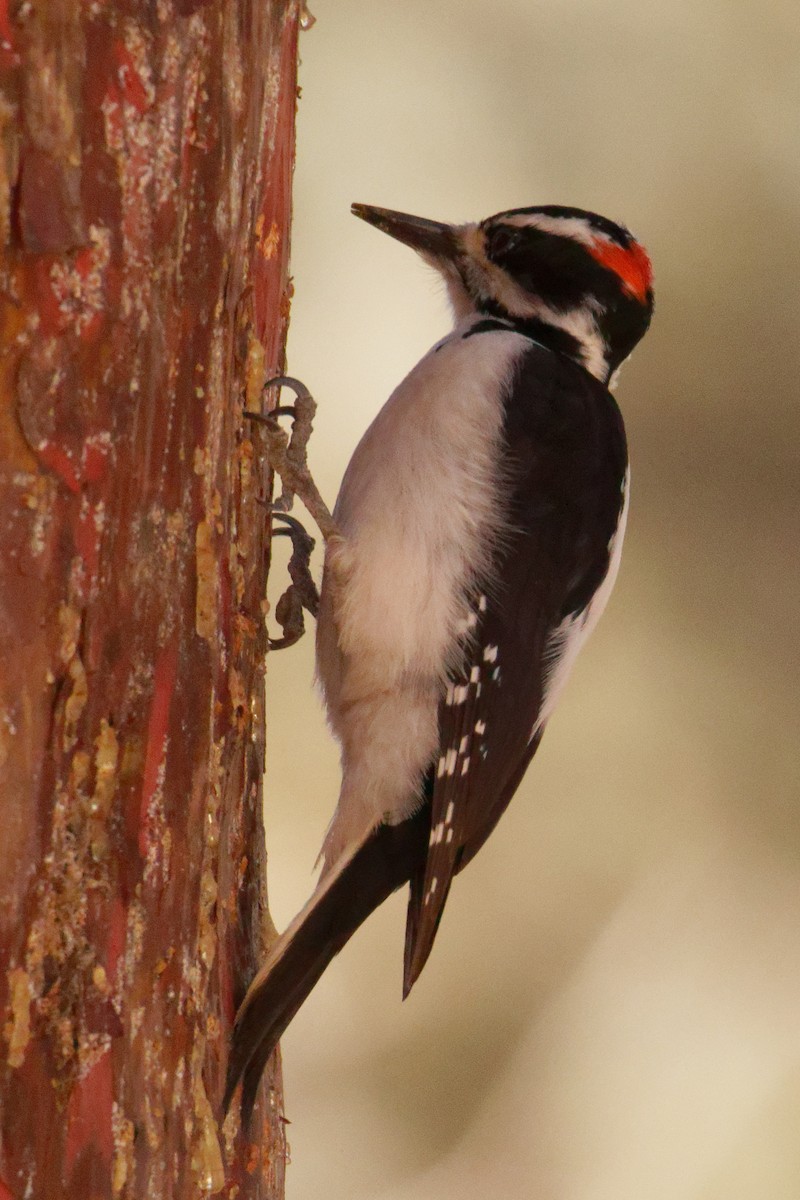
[{"x1": 404, "y1": 343, "x2": 627, "y2": 994}]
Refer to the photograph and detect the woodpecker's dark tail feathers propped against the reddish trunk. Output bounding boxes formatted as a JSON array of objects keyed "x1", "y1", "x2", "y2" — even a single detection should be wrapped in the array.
[{"x1": 223, "y1": 806, "x2": 431, "y2": 1124}]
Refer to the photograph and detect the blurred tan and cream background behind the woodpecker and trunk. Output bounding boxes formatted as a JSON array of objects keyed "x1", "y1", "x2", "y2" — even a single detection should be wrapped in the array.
[{"x1": 262, "y1": 0, "x2": 800, "y2": 1200}]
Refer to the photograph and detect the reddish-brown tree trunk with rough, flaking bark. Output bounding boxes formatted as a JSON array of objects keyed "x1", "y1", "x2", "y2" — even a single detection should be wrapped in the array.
[{"x1": 0, "y1": 0, "x2": 299, "y2": 1200}]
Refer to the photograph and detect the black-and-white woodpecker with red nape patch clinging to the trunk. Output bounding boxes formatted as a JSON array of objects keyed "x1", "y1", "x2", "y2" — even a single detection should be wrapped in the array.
[{"x1": 224, "y1": 204, "x2": 652, "y2": 1120}]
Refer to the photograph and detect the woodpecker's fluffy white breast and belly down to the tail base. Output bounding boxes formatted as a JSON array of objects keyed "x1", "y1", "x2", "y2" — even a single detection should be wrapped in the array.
[{"x1": 317, "y1": 326, "x2": 528, "y2": 870}]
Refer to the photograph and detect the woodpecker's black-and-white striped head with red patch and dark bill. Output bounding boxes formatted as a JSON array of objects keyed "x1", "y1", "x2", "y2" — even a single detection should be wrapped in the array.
[{"x1": 353, "y1": 204, "x2": 652, "y2": 383}]
